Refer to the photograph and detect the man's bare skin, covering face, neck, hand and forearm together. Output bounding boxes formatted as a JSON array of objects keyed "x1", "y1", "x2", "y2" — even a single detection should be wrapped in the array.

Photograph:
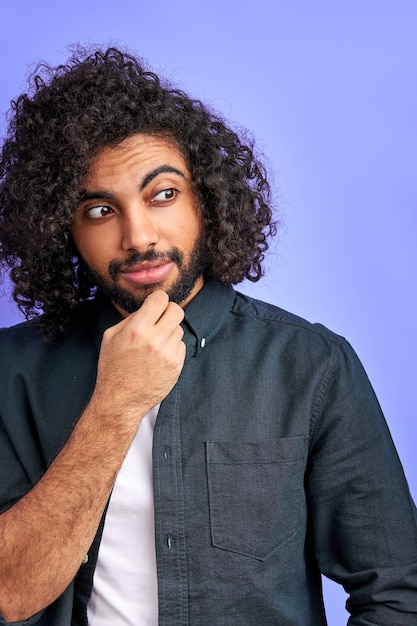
[{"x1": 0, "y1": 135, "x2": 203, "y2": 622}]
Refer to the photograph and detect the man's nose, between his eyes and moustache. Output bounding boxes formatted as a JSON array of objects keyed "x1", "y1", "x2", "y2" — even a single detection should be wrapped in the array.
[{"x1": 121, "y1": 207, "x2": 159, "y2": 254}]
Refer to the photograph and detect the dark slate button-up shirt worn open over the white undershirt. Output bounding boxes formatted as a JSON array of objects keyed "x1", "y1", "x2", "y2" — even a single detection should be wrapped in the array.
[{"x1": 0, "y1": 280, "x2": 417, "y2": 626}]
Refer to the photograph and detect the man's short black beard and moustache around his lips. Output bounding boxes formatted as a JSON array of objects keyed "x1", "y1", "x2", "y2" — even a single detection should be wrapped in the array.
[{"x1": 84, "y1": 234, "x2": 207, "y2": 314}]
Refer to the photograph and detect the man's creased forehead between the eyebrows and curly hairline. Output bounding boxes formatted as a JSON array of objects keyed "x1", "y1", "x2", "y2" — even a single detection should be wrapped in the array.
[{"x1": 85, "y1": 133, "x2": 189, "y2": 182}]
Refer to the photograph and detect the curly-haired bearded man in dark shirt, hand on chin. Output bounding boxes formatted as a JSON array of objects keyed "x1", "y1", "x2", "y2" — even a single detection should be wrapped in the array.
[{"x1": 0, "y1": 49, "x2": 417, "y2": 626}]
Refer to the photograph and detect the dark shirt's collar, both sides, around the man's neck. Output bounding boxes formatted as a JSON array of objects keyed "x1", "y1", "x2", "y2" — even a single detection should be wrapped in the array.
[{"x1": 94, "y1": 278, "x2": 235, "y2": 360}]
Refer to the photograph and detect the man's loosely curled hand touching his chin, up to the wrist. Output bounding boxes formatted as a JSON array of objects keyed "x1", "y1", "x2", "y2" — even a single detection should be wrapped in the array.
[{"x1": 93, "y1": 291, "x2": 185, "y2": 425}]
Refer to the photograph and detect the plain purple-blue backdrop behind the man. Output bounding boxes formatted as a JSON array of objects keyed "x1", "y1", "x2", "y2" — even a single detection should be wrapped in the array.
[{"x1": 0, "y1": 0, "x2": 417, "y2": 626}]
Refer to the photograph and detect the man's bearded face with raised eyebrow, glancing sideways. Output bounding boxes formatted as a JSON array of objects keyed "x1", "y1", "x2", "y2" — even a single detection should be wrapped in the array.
[{"x1": 72, "y1": 134, "x2": 205, "y2": 315}]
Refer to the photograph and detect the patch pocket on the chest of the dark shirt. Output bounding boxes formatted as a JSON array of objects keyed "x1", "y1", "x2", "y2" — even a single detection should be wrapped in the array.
[{"x1": 206, "y1": 437, "x2": 307, "y2": 561}]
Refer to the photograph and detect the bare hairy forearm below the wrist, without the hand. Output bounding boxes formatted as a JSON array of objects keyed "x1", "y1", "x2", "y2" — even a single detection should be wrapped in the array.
[{"x1": 0, "y1": 400, "x2": 139, "y2": 621}]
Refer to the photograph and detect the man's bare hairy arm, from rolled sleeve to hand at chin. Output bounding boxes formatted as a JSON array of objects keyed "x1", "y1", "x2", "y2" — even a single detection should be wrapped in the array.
[{"x1": 0, "y1": 292, "x2": 185, "y2": 621}]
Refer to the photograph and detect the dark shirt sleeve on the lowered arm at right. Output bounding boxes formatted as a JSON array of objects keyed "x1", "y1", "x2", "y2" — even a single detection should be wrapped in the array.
[{"x1": 306, "y1": 342, "x2": 417, "y2": 626}]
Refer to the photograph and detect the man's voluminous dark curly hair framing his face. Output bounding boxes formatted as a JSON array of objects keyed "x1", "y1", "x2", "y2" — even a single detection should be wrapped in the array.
[{"x1": 0, "y1": 47, "x2": 276, "y2": 340}]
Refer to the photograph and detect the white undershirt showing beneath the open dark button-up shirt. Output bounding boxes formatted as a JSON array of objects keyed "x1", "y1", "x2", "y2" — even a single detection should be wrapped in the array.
[{"x1": 87, "y1": 405, "x2": 159, "y2": 626}]
